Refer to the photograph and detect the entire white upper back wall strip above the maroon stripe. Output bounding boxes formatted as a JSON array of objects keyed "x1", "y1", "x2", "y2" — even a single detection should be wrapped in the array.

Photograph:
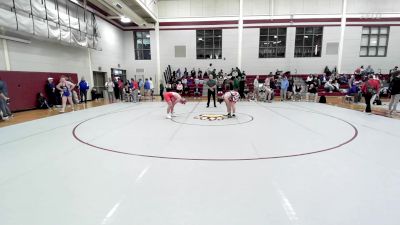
[{"x1": 158, "y1": 0, "x2": 400, "y2": 19}]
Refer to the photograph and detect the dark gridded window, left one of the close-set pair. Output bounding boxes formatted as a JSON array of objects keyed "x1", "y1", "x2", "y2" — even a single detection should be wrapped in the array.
[{"x1": 258, "y1": 28, "x2": 286, "y2": 58}]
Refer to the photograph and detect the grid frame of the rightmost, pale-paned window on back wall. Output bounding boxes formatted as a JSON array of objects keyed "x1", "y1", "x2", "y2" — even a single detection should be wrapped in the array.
[{"x1": 359, "y1": 26, "x2": 390, "y2": 57}]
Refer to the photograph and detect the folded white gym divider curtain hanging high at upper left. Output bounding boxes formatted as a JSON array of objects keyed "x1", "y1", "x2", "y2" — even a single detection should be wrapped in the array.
[{"x1": 0, "y1": 0, "x2": 99, "y2": 48}]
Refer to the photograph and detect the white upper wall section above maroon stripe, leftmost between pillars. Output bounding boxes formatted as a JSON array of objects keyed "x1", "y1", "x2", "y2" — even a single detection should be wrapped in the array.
[{"x1": 158, "y1": 0, "x2": 239, "y2": 18}]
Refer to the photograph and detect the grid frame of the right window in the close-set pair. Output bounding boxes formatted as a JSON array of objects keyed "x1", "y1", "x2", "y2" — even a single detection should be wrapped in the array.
[{"x1": 294, "y1": 26, "x2": 324, "y2": 58}]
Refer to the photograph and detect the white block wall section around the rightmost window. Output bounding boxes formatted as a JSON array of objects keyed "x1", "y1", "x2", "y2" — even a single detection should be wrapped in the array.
[{"x1": 342, "y1": 26, "x2": 400, "y2": 73}]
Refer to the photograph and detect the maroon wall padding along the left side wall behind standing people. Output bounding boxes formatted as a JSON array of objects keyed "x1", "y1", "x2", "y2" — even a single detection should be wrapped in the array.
[{"x1": 0, "y1": 71, "x2": 78, "y2": 111}]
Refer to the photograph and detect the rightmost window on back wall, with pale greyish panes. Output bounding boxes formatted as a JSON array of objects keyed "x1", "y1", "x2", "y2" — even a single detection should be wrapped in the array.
[{"x1": 360, "y1": 27, "x2": 389, "y2": 57}]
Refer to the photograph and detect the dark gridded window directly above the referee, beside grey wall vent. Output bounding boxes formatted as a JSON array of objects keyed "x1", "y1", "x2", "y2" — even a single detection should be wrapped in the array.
[{"x1": 196, "y1": 30, "x2": 222, "y2": 59}]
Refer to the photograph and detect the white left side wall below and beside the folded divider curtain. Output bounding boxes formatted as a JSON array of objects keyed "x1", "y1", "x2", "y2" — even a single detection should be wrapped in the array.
[{"x1": 0, "y1": 17, "x2": 126, "y2": 98}]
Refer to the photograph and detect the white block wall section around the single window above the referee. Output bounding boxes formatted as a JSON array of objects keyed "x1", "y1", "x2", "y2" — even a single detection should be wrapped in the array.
[{"x1": 160, "y1": 29, "x2": 238, "y2": 72}]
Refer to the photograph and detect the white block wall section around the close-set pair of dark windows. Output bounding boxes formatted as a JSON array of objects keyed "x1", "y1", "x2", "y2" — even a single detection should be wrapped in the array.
[{"x1": 242, "y1": 27, "x2": 340, "y2": 74}]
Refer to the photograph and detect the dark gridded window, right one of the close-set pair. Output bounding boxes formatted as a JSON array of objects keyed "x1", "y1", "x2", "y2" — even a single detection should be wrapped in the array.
[{"x1": 294, "y1": 27, "x2": 323, "y2": 57}]
